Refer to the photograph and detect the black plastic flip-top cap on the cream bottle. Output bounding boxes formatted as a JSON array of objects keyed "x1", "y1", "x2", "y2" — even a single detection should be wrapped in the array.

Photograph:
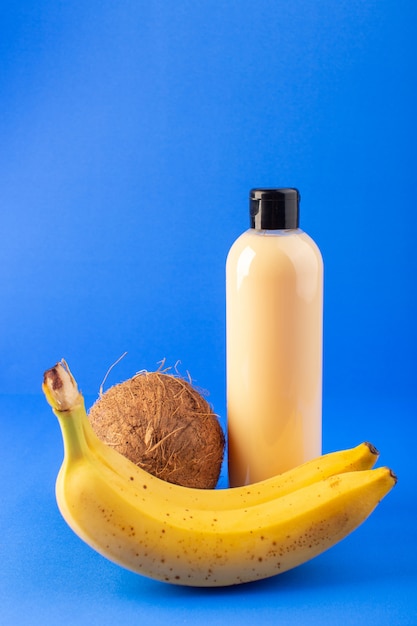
[{"x1": 249, "y1": 188, "x2": 300, "y2": 230}]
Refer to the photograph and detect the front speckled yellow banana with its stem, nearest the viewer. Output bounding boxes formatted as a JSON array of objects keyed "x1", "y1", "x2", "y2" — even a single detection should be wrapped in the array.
[{"x1": 43, "y1": 363, "x2": 396, "y2": 586}]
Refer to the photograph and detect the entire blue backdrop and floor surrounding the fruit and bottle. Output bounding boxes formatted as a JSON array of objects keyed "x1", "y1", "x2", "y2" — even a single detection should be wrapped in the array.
[{"x1": 0, "y1": 0, "x2": 417, "y2": 625}]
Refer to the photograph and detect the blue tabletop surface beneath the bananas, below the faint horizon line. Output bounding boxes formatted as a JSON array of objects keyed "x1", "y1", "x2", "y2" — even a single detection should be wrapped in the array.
[{"x1": 0, "y1": 396, "x2": 417, "y2": 626}]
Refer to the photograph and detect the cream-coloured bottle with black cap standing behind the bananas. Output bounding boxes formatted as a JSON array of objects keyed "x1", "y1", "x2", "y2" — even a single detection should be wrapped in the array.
[{"x1": 226, "y1": 188, "x2": 323, "y2": 487}]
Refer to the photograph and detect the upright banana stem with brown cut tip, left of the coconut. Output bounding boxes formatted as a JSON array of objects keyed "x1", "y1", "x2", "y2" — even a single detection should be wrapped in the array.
[{"x1": 42, "y1": 360, "x2": 88, "y2": 460}]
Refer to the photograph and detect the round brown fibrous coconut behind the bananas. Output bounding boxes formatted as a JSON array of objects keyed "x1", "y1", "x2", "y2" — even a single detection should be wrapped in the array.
[{"x1": 89, "y1": 372, "x2": 225, "y2": 489}]
